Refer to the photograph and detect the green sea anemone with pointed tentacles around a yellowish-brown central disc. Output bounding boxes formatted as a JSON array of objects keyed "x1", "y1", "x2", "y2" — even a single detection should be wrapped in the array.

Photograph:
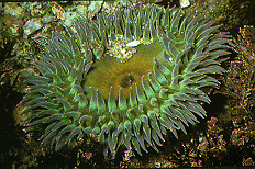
[{"x1": 20, "y1": 4, "x2": 229, "y2": 156}]
